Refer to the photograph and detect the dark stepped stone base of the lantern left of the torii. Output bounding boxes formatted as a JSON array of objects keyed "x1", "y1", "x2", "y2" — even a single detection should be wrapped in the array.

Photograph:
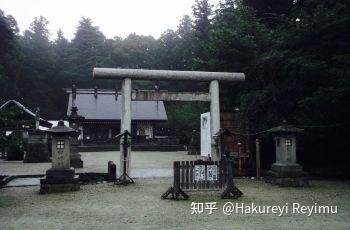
[{"x1": 40, "y1": 169, "x2": 80, "y2": 194}]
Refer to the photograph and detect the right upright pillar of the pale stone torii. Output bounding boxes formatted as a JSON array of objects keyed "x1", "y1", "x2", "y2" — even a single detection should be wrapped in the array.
[{"x1": 209, "y1": 80, "x2": 221, "y2": 161}]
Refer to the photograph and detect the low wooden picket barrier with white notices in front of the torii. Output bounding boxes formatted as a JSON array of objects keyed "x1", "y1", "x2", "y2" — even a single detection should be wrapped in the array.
[{"x1": 162, "y1": 159, "x2": 242, "y2": 200}]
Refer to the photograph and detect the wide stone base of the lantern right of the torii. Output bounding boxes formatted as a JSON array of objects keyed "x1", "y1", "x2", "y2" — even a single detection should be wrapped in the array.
[{"x1": 265, "y1": 164, "x2": 309, "y2": 187}]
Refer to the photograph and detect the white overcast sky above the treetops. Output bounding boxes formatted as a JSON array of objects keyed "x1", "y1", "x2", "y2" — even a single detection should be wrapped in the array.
[{"x1": 0, "y1": 0, "x2": 219, "y2": 39}]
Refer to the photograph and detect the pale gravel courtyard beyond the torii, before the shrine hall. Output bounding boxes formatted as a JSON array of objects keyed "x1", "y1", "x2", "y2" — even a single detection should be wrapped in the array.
[{"x1": 0, "y1": 151, "x2": 196, "y2": 177}]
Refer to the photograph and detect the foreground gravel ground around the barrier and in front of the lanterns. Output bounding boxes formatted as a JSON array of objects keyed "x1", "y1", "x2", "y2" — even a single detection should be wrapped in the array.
[{"x1": 0, "y1": 178, "x2": 350, "y2": 229}]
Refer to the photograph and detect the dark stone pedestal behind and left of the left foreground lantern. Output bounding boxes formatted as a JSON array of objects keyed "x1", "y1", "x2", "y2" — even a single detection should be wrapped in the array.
[{"x1": 23, "y1": 130, "x2": 50, "y2": 163}]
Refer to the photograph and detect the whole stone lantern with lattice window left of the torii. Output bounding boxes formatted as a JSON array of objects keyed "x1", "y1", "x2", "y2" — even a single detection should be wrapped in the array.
[{"x1": 40, "y1": 121, "x2": 80, "y2": 193}]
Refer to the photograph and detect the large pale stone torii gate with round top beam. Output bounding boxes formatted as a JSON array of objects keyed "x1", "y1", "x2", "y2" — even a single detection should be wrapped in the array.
[{"x1": 93, "y1": 68, "x2": 245, "y2": 174}]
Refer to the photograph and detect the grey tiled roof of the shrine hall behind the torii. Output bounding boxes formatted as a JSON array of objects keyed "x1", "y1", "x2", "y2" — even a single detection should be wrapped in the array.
[{"x1": 67, "y1": 90, "x2": 168, "y2": 121}]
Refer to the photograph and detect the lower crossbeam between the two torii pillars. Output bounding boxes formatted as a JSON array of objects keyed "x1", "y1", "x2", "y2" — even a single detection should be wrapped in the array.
[{"x1": 131, "y1": 90, "x2": 210, "y2": 101}]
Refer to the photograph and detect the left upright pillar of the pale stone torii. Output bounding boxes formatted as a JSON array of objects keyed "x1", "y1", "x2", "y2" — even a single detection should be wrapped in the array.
[{"x1": 119, "y1": 78, "x2": 131, "y2": 175}]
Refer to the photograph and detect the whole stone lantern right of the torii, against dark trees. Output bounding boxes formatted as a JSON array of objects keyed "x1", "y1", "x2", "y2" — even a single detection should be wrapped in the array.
[{"x1": 266, "y1": 121, "x2": 309, "y2": 186}]
